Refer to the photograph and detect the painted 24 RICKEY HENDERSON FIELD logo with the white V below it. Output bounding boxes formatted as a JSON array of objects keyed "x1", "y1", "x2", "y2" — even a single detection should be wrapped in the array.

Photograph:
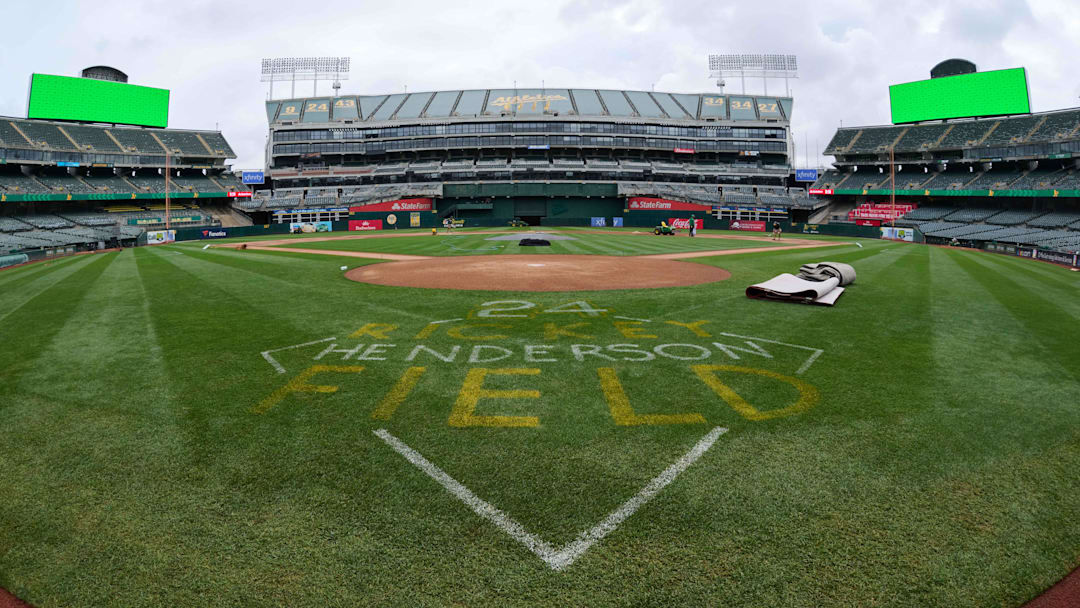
[{"x1": 252, "y1": 300, "x2": 824, "y2": 571}]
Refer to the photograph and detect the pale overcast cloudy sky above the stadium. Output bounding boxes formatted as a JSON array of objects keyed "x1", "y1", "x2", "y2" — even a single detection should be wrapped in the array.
[{"x1": 0, "y1": 0, "x2": 1080, "y2": 168}]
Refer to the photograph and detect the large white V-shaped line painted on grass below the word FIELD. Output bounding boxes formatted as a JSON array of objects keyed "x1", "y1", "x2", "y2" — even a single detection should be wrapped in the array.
[{"x1": 375, "y1": 427, "x2": 728, "y2": 571}]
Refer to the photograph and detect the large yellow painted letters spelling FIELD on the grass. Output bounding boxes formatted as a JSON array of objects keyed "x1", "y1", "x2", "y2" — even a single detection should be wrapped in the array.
[{"x1": 252, "y1": 365, "x2": 820, "y2": 428}]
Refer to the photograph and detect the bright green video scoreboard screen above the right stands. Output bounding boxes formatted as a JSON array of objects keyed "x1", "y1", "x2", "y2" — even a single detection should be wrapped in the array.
[{"x1": 889, "y1": 68, "x2": 1031, "y2": 124}]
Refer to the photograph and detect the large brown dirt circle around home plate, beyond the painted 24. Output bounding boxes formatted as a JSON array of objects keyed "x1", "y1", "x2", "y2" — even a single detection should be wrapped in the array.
[{"x1": 346, "y1": 255, "x2": 731, "y2": 292}]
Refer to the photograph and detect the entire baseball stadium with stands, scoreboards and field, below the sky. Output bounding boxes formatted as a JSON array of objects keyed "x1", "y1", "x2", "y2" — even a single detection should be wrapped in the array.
[{"x1": 0, "y1": 55, "x2": 1080, "y2": 608}]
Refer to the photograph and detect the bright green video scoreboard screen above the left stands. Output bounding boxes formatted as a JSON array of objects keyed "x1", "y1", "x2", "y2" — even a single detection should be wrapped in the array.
[{"x1": 26, "y1": 73, "x2": 168, "y2": 127}]
